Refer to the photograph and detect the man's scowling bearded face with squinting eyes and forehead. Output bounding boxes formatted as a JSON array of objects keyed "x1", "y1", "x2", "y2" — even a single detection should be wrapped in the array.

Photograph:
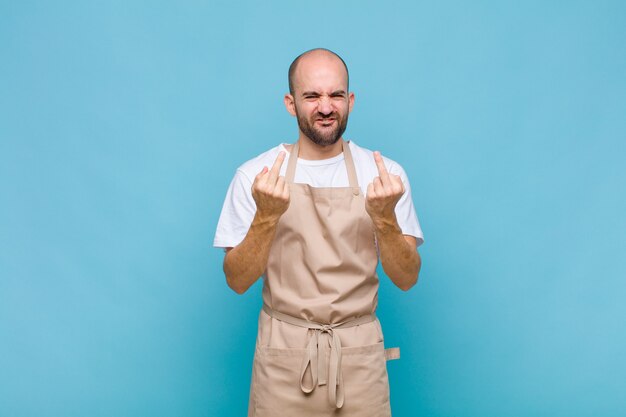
[{"x1": 286, "y1": 54, "x2": 354, "y2": 146}]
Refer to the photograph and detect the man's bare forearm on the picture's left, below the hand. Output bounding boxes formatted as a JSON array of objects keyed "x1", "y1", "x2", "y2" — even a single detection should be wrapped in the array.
[{"x1": 224, "y1": 213, "x2": 278, "y2": 294}]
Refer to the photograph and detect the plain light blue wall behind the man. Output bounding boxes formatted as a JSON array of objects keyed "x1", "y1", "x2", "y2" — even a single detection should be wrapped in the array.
[{"x1": 0, "y1": 0, "x2": 626, "y2": 417}]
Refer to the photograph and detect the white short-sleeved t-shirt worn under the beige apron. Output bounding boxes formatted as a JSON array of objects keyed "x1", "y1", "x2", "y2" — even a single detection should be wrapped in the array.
[{"x1": 213, "y1": 141, "x2": 424, "y2": 248}]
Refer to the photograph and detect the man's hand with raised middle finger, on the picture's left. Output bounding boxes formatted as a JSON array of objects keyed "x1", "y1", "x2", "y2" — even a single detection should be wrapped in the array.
[{"x1": 252, "y1": 151, "x2": 289, "y2": 221}]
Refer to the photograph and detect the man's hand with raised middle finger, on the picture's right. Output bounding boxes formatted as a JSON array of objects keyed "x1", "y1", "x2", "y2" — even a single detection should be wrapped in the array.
[{"x1": 365, "y1": 151, "x2": 404, "y2": 226}]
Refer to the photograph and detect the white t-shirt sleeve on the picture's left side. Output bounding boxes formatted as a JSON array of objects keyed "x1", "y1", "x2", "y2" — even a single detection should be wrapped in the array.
[{"x1": 213, "y1": 169, "x2": 256, "y2": 248}]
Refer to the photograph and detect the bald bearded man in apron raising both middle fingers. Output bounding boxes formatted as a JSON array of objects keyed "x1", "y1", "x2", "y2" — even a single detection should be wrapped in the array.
[{"x1": 214, "y1": 49, "x2": 423, "y2": 417}]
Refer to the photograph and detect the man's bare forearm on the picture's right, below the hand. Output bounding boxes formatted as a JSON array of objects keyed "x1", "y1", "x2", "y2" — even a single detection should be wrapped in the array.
[{"x1": 374, "y1": 216, "x2": 421, "y2": 291}]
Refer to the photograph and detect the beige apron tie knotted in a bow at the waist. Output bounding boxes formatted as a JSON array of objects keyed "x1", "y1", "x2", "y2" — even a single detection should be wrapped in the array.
[{"x1": 263, "y1": 304, "x2": 376, "y2": 408}]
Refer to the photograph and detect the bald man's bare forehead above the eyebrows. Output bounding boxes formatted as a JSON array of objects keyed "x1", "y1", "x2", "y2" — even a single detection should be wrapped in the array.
[{"x1": 294, "y1": 52, "x2": 348, "y2": 92}]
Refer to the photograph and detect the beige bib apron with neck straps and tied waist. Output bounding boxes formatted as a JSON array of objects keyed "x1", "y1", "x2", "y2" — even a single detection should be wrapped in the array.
[{"x1": 248, "y1": 140, "x2": 399, "y2": 417}]
